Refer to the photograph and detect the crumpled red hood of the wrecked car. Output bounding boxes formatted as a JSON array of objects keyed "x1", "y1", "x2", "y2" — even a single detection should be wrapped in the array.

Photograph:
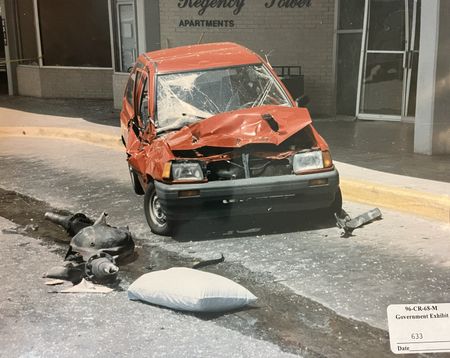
[{"x1": 165, "y1": 106, "x2": 311, "y2": 150}]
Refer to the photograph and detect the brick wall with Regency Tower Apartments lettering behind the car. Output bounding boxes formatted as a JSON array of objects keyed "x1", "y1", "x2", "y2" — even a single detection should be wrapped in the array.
[{"x1": 160, "y1": 0, "x2": 335, "y2": 115}]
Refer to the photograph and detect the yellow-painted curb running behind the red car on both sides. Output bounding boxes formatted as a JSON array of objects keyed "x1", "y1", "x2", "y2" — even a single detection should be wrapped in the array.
[{"x1": 0, "y1": 127, "x2": 450, "y2": 224}]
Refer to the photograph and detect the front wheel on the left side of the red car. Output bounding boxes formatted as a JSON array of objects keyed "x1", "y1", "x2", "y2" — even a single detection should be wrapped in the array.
[{"x1": 144, "y1": 183, "x2": 175, "y2": 236}]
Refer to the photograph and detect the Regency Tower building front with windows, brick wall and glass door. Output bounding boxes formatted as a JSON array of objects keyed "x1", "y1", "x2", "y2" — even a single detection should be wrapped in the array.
[{"x1": 0, "y1": 0, "x2": 450, "y2": 154}]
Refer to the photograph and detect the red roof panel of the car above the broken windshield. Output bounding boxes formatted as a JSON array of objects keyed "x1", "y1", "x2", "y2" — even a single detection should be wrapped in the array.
[{"x1": 139, "y1": 42, "x2": 263, "y2": 73}]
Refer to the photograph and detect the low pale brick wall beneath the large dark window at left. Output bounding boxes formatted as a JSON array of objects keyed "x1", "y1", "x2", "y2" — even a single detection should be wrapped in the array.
[{"x1": 17, "y1": 65, "x2": 113, "y2": 98}]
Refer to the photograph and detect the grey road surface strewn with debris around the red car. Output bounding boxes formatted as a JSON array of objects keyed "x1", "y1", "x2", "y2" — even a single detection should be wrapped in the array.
[{"x1": 0, "y1": 137, "x2": 450, "y2": 357}]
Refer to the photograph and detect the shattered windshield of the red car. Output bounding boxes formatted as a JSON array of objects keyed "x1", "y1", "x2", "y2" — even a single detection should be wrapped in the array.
[{"x1": 157, "y1": 65, "x2": 291, "y2": 132}]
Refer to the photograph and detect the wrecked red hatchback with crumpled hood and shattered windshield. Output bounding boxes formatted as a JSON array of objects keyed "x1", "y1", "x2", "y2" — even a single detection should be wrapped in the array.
[{"x1": 120, "y1": 43, "x2": 342, "y2": 235}]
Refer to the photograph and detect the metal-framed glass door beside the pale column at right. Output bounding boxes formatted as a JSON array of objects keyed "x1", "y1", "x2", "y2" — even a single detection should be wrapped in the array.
[{"x1": 357, "y1": 0, "x2": 418, "y2": 121}]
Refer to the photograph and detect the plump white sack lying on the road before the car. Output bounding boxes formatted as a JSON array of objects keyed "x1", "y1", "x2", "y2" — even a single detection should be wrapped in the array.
[{"x1": 128, "y1": 267, "x2": 257, "y2": 312}]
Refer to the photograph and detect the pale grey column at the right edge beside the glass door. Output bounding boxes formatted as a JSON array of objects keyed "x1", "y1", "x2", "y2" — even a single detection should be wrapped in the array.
[{"x1": 414, "y1": 0, "x2": 450, "y2": 155}]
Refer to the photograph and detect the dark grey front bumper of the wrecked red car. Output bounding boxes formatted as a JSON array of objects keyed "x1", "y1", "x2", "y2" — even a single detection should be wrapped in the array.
[{"x1": 155, "y1": 169, "x2": 339, "y2": 220}]
